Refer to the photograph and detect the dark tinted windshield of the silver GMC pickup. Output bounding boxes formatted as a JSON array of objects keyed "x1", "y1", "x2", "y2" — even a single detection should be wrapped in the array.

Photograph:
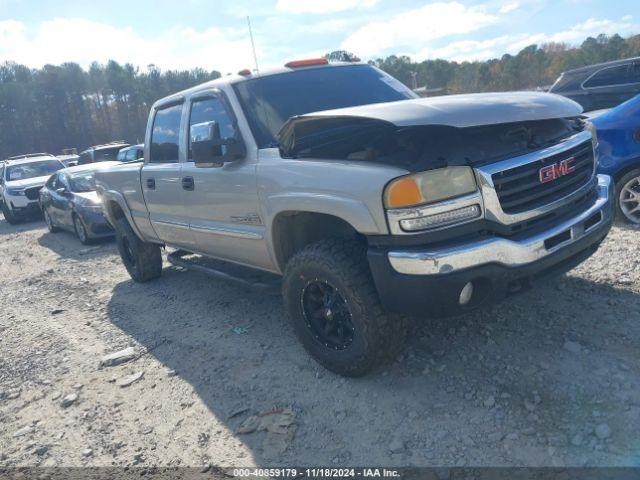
[{"x1": 234, "y1": 65, "x2": 416, "y2": 148}]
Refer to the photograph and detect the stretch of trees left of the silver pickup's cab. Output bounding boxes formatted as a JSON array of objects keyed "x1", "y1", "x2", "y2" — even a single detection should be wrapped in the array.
[{"x1": 0, "y1": 61, "x2": 220, "y2": 159}]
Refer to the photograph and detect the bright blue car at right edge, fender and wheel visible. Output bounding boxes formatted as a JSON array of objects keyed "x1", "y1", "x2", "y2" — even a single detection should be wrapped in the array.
[{"x1": 592, "y1": 95, "x2": 640, "y2": 224}]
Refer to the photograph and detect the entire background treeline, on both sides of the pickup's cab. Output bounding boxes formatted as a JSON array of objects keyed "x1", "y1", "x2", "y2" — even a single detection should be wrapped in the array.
[{"x1": 0, "y1": 35, "x2": 640, "y2": 159}]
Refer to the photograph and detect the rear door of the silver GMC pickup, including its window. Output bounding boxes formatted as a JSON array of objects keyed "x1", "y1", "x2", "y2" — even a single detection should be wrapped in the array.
[{"x1": 140, "y1": 102, "x2": 194, "y2": 248}]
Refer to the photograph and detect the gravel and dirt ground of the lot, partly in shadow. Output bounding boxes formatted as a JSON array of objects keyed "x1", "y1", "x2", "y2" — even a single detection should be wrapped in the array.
[{"x1": 0, "y1": 212, "x2": 640, "y2": 466}]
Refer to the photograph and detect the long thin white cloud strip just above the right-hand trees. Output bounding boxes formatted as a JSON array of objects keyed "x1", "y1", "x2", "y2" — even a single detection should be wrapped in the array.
[{"x1": 406, "y1": 15, "x2": 640, "y2": 62}]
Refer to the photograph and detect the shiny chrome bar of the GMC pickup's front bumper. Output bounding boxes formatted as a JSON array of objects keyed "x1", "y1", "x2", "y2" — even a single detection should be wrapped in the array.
[{"x1": 388, "y1": 175, "x2": 613, "y2": 275}]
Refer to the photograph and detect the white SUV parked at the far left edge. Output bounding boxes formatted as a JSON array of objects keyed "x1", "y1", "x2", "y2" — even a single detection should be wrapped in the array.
[{"x1": 0, "y1": 153, "x2": 64, "y2": 225}]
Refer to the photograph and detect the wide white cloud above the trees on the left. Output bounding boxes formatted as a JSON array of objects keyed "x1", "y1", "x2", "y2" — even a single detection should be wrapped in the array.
[{"x1": 0, "y1": 18, "x2": 253, "y2": 74}]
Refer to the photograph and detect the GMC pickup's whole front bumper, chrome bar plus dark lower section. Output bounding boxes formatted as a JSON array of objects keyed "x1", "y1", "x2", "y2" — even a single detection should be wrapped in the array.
[{"x1": 368, "y1": 175, "x2": 613, "y2": 316}]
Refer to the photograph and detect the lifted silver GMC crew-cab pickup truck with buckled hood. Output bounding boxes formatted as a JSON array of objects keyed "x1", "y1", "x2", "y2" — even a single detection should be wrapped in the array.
[{"x1": 96, "y1": 59, "x2": 612, "y2": 376}]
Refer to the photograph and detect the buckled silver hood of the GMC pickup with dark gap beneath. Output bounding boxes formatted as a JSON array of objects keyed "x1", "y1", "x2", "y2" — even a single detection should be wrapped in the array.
[{"x1": 278, "y1": 92, "x2": 583, "y2": 171}]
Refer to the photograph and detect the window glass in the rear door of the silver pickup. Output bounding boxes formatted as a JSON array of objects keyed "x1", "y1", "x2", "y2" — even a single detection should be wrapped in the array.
[{"x1": 149, "y1": 104, "x2": 182, "y2": 163}]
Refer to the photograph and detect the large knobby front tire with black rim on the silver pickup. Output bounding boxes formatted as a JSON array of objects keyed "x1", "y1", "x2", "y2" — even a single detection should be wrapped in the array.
[{"x1": 283, "y1": 239, "x2": 406, "y2": 377}]
